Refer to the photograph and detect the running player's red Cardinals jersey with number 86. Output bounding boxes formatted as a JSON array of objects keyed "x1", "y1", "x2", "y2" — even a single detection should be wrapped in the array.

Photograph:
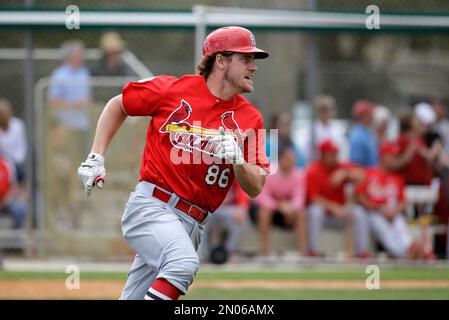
[{"x1": 122, "y1": 75, "x2": 269, "y2": 212}]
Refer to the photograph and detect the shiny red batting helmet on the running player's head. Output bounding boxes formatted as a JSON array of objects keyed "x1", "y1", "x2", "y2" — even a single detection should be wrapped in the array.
[{"x1": 203, "y1": 27, "x2": 269, "y2": 59}]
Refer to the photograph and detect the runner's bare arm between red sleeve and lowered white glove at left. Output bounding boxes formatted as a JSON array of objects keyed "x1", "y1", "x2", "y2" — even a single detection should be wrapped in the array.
[{"x1": 91, "y1": 95, "x2": 128, "y2": 155}]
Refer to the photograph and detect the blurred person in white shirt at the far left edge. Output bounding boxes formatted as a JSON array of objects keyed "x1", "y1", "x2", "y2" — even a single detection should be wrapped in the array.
[{"x1": 0, "y1": 99, "x2": 28, "y2": 191}]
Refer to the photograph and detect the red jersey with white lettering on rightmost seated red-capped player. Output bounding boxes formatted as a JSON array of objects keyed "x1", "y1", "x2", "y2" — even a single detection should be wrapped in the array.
[{"x1": 355, "y1": 167, "x2": 405, "y2": 207}]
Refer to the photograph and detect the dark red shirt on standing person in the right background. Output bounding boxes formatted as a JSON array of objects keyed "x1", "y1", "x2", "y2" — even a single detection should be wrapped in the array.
[{"x1": 396, "y1": 135, "x2": 433, "y2": 185}]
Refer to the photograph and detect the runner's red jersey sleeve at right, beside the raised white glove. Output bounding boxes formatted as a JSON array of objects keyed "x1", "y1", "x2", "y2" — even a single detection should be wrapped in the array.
[{"x1": 244, "y1": 118, "x2": 270, "y2": 173}]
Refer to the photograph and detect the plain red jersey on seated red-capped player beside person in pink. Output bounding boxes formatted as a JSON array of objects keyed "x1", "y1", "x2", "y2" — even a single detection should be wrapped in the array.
[{"x1": 306, "y1": 160, "x2": 355, "y2": 204}]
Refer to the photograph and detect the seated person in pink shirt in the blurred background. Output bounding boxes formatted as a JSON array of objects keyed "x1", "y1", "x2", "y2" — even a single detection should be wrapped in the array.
[{"x1": 256, "y1": 145, "x2": 306, "y2": 256}]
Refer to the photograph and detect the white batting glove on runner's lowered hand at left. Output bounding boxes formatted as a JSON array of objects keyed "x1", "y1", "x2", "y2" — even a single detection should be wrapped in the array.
[{"x1": 78, "y1": 152, "x2": 106, "y2": 197}]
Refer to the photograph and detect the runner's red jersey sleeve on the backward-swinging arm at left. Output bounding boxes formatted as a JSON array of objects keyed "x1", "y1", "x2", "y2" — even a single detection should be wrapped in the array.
[{"x1": 122, "y1": 75, "x2": 177, "y2": 116}]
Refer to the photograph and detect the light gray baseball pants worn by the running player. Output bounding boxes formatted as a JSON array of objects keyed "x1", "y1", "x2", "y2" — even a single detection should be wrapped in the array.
[{"x1": 120, "y1": 181, "x2": 209, "y2": 300}]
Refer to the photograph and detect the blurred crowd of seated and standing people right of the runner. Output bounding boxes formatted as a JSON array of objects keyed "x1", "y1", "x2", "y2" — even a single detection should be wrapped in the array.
[{"x1": 202, "y1": 99, "x2": 449, "y2": 260}]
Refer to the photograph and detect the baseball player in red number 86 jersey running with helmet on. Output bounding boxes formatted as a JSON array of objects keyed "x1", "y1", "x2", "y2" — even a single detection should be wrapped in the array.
[{"x1": 78, "y1": 27, "x2": 269, "y2": 300}]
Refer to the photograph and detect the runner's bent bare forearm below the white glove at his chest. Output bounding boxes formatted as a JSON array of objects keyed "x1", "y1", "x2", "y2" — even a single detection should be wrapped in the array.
[{"x1": 234, "y1": 163, "x2": 266, "y2": 199}]
